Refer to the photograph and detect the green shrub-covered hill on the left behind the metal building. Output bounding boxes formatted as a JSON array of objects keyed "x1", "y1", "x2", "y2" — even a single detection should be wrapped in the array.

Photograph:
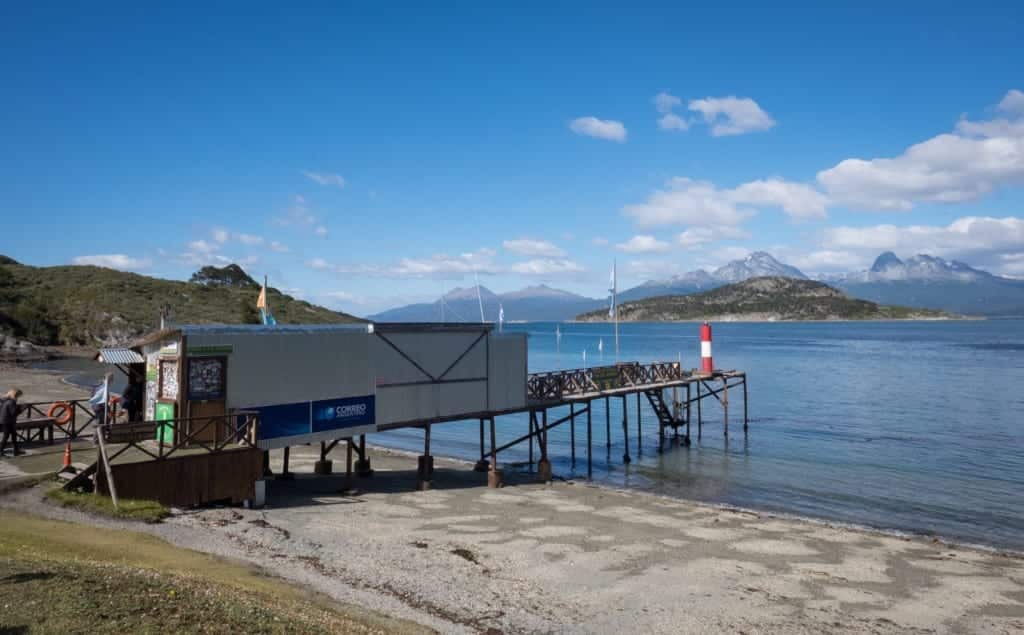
[{"x1": 0, "y1": 256, "x2": 362, "y2": 345}]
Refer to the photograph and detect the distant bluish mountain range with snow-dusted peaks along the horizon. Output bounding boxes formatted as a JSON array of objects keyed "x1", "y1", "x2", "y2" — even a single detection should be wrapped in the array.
[{"x1": 370, "y1": 251, "x2": 1024, "y2": 322}]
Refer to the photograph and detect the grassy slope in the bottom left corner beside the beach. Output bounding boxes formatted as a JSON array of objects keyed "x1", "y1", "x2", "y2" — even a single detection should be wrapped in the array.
[{"x1": 0, "y1": 510, "x2": 427, "y2": 633}]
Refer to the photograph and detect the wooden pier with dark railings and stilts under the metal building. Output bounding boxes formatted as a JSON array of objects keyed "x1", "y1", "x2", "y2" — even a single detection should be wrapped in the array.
[{"x1": 19, "y1": 363, "x2": 750, "y2": 506}]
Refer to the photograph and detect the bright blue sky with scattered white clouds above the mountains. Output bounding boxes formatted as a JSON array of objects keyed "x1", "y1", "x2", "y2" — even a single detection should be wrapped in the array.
[{"x1": 0, "y1": 2, "x2": 1024, "y2": 314}]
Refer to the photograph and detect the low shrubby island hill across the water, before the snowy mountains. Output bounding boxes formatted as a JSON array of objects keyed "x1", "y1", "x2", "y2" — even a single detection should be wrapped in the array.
[{"x1": 577, "y1": 277, "x2": 955, "y2": 322}]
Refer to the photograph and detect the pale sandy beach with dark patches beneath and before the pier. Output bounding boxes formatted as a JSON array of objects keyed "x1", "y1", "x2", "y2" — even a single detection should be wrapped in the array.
[{"x1": 0, "y1": 368, "x2": 1024, "y2": 633}]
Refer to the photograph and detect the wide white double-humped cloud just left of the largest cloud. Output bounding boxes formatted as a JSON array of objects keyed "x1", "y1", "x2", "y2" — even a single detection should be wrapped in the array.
[{"x1": 623, "y1": 177, "x2": 827, "y2": 227}]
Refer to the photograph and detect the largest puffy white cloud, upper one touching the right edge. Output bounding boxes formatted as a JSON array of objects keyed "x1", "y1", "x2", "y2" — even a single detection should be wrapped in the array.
[{"x1": 817, "y1": 90, "x2": 1024, "y2": 210}]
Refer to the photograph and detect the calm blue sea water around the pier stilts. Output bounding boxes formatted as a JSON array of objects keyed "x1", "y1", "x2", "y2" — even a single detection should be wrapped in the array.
[{"x1": 375, "y1": 320, "x2": 1024, "y2": 550}]
